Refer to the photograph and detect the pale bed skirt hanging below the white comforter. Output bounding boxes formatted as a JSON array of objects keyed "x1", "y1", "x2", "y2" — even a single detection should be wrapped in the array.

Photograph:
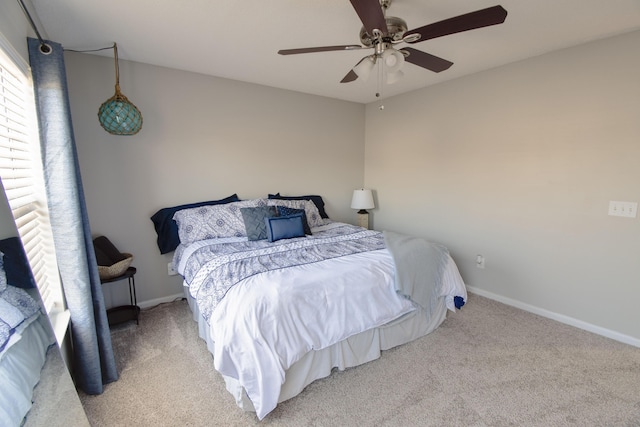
[{"x1": 184, "y1": 286, "x2": 447, "y2": 412}]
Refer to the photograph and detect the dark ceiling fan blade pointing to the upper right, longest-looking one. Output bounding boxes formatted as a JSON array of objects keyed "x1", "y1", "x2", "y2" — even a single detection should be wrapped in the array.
[{"x1": 404, "y1": 6, "x2": 507, "y2": 44}]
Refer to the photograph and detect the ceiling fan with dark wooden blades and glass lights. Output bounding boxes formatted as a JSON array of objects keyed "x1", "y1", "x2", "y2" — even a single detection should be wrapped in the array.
[{"x1": 278, "y1": 0, "x2": 507, "y2": 83}]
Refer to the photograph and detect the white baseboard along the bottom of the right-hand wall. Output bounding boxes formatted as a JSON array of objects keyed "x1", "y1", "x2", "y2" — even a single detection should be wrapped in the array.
[{"x1": 467, "y1": 286, "x2": 640, "y2": 347}]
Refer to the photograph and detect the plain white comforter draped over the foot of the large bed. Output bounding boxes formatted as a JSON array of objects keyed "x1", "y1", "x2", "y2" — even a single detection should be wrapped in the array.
[{"x1": 176, "y1": 224, "x2": 466, "y2": 419}]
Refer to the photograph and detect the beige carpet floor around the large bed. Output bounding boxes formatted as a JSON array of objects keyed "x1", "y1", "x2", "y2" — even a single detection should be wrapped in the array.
[{"x1": 80, "y1": 295, "x2": 640, "y2": 426}]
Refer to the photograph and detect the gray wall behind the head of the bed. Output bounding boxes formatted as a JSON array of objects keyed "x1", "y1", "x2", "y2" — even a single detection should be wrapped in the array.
[{"x1": 65, "y1": 53, "x2": 365, "y2": 306}]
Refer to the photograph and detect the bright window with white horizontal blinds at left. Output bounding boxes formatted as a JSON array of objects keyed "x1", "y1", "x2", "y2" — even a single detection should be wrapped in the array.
[{"x1": 0, "y1": 34, "x2": 68, "y2": 342}]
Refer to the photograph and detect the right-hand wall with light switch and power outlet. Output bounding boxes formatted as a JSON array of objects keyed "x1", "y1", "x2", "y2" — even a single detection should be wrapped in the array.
[{"x1": 365, "y1": 32, "x2": 640, "y2": 345}]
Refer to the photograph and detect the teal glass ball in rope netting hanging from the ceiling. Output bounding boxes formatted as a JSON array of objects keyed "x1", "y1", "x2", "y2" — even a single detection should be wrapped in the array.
[{"x1": 98, "y1": 43, "x2": 142, "y2": 135}]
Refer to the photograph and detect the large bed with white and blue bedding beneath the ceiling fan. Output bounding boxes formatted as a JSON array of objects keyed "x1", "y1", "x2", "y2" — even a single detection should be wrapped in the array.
[{"x1": 158, "y1": 195, "x2": 467, "y2": 419}]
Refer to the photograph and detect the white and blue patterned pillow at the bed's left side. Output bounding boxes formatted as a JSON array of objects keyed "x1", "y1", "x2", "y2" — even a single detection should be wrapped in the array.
[{"x1": 173, "y1": 199, "x2": 266, "y2": 245}]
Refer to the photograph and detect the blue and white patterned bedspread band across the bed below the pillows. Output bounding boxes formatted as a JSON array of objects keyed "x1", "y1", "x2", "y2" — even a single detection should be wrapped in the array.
[{"x1": 174, "y1": 224, "x2": 385, "y2": 321}]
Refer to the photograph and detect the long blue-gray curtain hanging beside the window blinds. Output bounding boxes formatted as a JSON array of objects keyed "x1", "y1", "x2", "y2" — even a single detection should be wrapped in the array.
[{"x1": 28, "y1": 38, "x2": 118, "y2": 394}]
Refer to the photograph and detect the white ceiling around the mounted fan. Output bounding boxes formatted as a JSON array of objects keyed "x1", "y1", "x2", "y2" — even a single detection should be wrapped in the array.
[{"x1": 31, "y1": 0, "x2": 640, "y2": 103}]
